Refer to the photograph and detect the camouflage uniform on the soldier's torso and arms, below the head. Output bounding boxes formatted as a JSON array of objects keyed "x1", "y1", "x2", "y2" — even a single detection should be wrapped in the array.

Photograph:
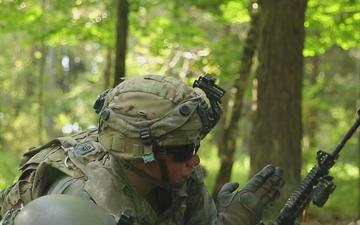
[{"x1": 1, "y1": 129, "x2": 216, "y2": 225}]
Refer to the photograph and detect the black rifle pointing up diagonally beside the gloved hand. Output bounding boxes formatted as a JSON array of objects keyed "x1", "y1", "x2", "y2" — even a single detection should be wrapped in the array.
[{"x1": 271, "y1": 108, "x2": 360, "y2": 225}]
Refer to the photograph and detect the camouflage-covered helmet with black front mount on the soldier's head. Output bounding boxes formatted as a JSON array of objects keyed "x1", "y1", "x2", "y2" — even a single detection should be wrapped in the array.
[{"x1": 94, "y1": 75, "x2": 224, "y2": 162}]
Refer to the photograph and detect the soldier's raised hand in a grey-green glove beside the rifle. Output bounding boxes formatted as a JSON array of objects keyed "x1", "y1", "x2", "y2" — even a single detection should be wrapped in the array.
[{"x1": 218, "y1": 165, "x2": 284, "y2": 225}]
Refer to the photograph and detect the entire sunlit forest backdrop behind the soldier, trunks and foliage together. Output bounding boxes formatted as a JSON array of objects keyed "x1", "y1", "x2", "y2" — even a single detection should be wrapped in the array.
[{"x1": 0, "y1": 0, "x2": 360, "y2": 224}]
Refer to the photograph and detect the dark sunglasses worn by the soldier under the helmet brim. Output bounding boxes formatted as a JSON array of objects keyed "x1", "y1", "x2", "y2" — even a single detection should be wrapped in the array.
[{"x1": 161, "y1": 144, "x2": 199, "y2": 163}]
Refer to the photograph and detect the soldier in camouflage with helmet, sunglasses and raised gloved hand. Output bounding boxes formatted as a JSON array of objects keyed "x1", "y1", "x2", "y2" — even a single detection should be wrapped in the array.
[{"x1": 0, "y1": 75, "x2": 283, "y2": 225}]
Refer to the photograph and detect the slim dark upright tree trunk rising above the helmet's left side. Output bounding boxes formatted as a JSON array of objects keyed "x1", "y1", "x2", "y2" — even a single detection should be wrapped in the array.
[{"x1": 113, "y1": 0, "x2": 128, "y2": 87}]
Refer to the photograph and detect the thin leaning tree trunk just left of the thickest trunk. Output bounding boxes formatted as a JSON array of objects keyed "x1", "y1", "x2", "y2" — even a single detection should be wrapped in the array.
[{"x1": 212, "y1": 4, "x2": 258, "y2": 199}]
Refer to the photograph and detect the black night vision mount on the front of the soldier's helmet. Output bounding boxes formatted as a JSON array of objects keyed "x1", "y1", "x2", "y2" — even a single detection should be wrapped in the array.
[{"x1": 193, "y1": 75, "x2": 225, "y2": 133}]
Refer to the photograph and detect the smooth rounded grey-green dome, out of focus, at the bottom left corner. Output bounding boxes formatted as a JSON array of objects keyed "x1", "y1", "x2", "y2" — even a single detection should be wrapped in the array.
[{"x1": 13, "y1": 195, "x2": 116, "y2": 225}]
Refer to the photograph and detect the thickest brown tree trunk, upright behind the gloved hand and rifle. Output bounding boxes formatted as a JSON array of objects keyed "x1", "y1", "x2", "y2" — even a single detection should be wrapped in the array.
[{"x1": 250, "y1": 0, "x2": 306, "y2": 213}]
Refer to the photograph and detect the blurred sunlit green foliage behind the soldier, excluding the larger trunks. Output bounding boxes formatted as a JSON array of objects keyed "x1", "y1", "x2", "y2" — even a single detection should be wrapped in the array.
[{"x1": 0, "y1": 0, "x2": 360, "y2": 222}]
